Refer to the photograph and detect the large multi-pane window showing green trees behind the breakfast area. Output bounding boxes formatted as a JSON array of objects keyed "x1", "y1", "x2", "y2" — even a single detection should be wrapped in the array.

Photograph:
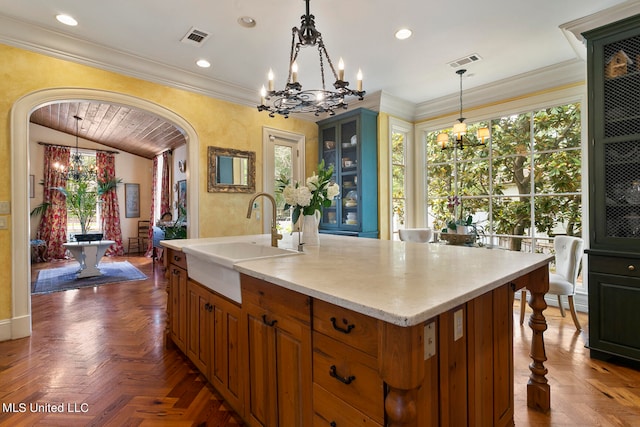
[{"x1": 425, "y1": 103, "x2": 582, "y2": 253}]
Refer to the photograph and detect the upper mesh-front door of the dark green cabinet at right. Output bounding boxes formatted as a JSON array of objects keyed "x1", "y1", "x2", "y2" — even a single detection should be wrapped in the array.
[{"x1": 585, "y1": 17, "x2": 640, "y2": 251}]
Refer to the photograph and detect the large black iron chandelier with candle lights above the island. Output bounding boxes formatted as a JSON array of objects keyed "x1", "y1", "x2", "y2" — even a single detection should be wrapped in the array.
[{"x1": 258, "y1": 0, "x2": 365, "y2": 118}]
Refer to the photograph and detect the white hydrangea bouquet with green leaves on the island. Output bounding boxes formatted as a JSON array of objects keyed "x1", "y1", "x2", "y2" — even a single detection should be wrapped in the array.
[{"x1": 277, "y1": 160, "x2": 340, "y2": 224}]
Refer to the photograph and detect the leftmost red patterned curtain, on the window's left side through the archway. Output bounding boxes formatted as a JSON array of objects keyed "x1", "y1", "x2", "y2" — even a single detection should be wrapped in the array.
[{"x1": 37, "y1": 145, "x2": 69, "y2": 260}]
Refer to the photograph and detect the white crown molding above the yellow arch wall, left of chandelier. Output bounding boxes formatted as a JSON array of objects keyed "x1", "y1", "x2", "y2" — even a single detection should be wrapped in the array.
[{"x1": 0, "y1": 15, "x2": 258, "y2": 107}]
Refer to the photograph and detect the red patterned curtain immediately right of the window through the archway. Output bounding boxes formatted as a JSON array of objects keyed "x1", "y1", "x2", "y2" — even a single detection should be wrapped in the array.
[{"x1": 96, "y1": 151, "x2": 124, "y2": 256}]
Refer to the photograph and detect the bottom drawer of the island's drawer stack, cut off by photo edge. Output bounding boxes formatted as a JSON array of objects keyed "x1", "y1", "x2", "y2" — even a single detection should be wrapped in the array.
[{"x1": 313, "y1": 384, "x2": 382, "y2": 427}]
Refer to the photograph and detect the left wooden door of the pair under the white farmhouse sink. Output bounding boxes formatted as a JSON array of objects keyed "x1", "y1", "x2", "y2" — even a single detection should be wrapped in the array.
[{"x1": 187, "y1": 280, "x2": 212, "y2": 377}]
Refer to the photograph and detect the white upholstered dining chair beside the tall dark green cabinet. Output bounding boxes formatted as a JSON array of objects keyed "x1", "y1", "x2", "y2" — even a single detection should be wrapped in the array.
[{"x1": 520, "y1": 236, "x2": 584, "y2": 331}]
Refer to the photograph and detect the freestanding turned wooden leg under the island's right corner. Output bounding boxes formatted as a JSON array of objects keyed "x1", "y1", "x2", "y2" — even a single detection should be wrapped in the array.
[{"x1": 527, "y1": 267, "x2": 551, "y2": 412}]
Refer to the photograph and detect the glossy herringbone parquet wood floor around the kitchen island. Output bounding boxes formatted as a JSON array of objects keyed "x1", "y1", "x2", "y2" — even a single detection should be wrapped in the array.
[{"x1": 0, "y1": 257, "x2": 640, "y2": 427}]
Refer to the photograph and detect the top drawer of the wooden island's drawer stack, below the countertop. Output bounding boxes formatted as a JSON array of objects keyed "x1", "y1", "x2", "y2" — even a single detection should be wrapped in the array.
[{"x1": 313, "y1": 299, "x2": 379, "y2": 357}]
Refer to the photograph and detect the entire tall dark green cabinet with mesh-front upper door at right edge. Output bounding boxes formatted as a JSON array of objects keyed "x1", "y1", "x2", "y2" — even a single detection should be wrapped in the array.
[{"x1": 583, "y1": 15, "x2": 640, "y2": 360}]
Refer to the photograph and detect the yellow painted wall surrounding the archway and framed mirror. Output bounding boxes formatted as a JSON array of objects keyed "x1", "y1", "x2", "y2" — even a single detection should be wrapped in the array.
[{"x1": 0, "y1": 45, "x2": 318, "y2": 321}]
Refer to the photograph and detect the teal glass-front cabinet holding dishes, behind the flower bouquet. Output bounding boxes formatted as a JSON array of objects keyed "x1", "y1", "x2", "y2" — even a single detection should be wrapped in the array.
[{"x1": 318, "y1": 108, "x2": 378, "y2": 238}]
